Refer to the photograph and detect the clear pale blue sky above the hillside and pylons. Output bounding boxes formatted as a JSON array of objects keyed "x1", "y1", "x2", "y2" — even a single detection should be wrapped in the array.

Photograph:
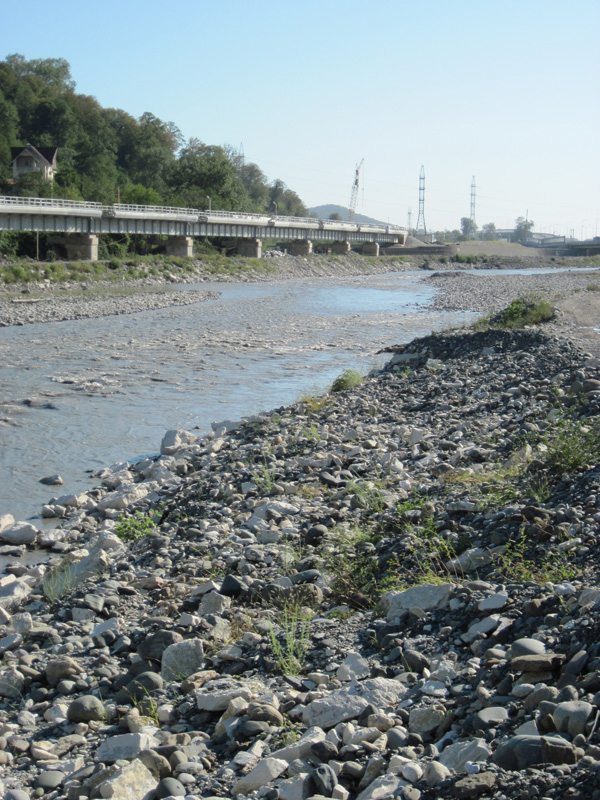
[{"x1": 0, "y1": 0, "x2": 600, "y2": 237}]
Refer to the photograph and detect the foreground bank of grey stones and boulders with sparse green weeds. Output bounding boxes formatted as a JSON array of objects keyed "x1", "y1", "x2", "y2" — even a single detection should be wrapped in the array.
[{"x1": 0, "y1": 316, "x2": 600, "y2": 800}]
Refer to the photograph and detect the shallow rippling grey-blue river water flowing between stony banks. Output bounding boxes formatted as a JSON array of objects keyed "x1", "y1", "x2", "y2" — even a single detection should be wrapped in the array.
[{"x1": 0, "y1": 272, "x2": 473, "y2": 519}]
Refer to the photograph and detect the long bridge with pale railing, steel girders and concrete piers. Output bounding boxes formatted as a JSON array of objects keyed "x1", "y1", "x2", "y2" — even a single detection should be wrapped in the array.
[{"x1": 0, "y1": 197, "x2": 407, "y2": 260}]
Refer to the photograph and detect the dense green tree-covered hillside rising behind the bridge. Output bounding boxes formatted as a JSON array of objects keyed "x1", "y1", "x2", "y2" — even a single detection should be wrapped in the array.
[{"x1": 0, "y1": 54, "x2": 307, "y2": 216}]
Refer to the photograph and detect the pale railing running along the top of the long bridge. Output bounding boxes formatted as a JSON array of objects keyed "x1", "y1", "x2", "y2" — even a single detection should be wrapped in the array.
[{"x1": 0, "y1": 197, "x2": 405, "y2": 233}]
